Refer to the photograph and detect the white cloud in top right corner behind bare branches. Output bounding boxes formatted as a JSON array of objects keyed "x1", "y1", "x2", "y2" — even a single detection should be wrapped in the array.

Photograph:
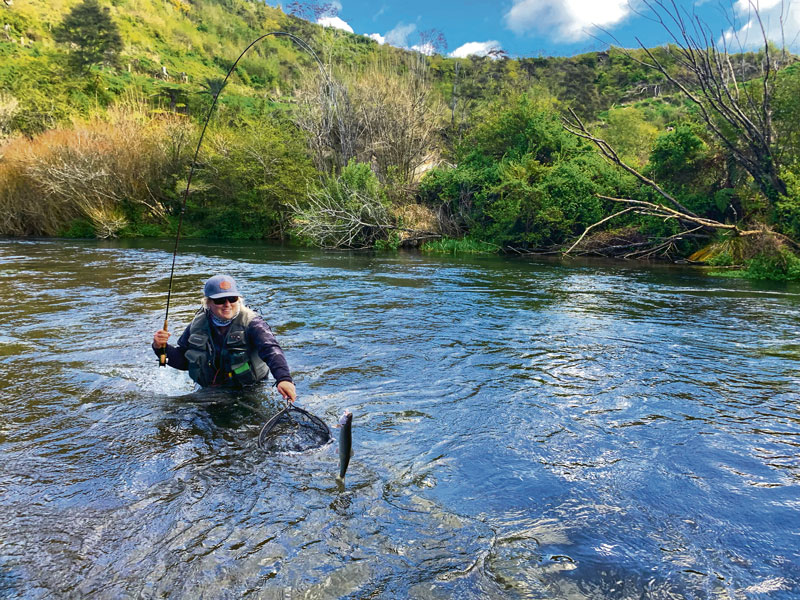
[{"x1": 723, "y1": 0, "x2": 800, "y2": 52}]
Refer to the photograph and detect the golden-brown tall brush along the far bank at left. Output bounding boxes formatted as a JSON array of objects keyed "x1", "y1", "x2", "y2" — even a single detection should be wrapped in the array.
[{"x1": 0, "y1": 99, "x2": 193, "y2": 237}]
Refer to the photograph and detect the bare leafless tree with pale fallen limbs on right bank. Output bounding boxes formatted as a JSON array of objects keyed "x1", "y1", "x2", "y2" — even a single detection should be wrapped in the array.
[{"x1": 564, "y1": 0, "x2": 794, "y2": 253}]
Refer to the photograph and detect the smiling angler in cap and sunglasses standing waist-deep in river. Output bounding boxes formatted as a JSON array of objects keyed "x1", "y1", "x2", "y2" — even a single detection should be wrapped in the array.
[{"x1": 152, "y1": 275, "x2": 297, "y2": 402}]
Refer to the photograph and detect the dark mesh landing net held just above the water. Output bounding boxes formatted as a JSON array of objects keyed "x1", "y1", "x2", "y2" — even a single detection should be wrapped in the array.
[{"x1": 258, "y1": 406, "x2": 331, "y2": 452}]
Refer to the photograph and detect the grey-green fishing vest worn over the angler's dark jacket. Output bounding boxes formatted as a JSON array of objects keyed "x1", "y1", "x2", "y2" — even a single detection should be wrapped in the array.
[{"x1": 185, "y1": 307, "x2": 269, "y2": 387}]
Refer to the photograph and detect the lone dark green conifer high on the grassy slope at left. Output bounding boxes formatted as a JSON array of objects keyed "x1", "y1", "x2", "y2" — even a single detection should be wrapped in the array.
[{"x1": 53, "y1": 0, "x2": 122, "y2": 70}]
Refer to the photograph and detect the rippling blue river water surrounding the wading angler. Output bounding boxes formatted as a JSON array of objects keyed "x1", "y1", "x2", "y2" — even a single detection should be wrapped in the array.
[{"x1": 0, "y1": 240, "x2": 800, "y2": 600}]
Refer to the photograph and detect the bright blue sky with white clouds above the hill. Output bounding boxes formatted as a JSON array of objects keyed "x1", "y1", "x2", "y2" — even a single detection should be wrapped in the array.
[{"x1": 284, "y1": 0, "x2": 800, "y2": 57}]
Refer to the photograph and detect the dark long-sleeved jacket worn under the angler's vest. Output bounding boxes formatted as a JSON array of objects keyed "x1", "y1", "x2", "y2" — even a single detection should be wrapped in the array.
[{"x1": 153, "y1": 308, "x2": 292, "y2": 385}]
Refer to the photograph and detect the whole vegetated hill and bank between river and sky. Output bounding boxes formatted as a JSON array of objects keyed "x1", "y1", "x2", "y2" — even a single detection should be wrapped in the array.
[{"x1": 0, "y1": 0, "x2": 800, "y2": 276}]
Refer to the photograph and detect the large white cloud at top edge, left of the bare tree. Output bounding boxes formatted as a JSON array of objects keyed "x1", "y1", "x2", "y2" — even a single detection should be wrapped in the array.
[{"x1": 505, "y1": 0, "x2": 632, "y2": 42}]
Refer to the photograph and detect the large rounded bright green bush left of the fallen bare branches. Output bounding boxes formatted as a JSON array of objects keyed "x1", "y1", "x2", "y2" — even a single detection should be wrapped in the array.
[{"x1": 420, "y1": 93, "x2": 636, "y2": 247}]
